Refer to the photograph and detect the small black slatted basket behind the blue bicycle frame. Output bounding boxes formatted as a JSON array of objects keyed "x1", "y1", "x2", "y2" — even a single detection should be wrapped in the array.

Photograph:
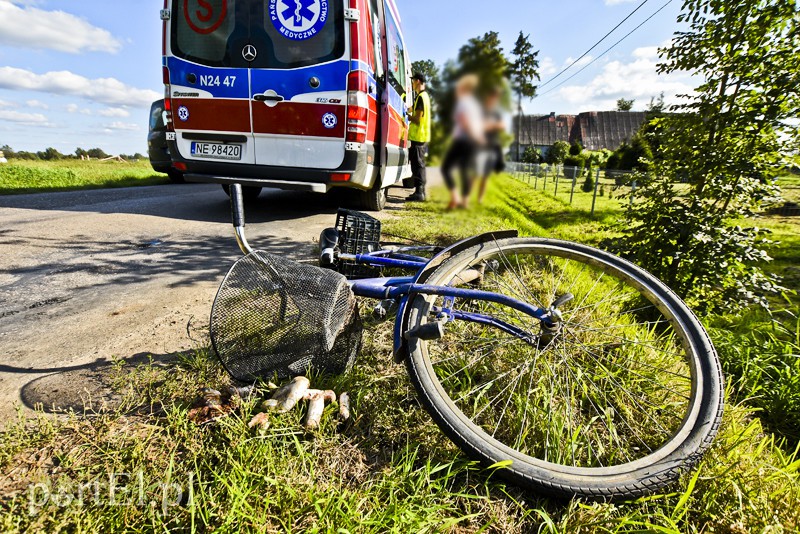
[{"x1": 336, "y1": 208, "x2": 382, "y2": 280}]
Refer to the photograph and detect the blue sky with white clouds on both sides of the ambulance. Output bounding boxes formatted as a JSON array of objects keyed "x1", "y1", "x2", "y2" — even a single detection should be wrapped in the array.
[{"x1": 0, "y1": 0, "x2": 692, "y2": 154}]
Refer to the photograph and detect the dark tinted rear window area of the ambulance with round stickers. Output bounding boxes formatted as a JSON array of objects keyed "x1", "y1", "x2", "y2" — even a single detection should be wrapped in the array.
[{"x1": 172, "y1": 0, "x2": 346, "y2": 69}]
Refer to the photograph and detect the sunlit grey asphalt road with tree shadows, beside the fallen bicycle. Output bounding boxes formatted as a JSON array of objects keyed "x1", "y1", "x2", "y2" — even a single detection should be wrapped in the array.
[{"x1": 0, "y1": 184, "x2": 412, "y2": 425}]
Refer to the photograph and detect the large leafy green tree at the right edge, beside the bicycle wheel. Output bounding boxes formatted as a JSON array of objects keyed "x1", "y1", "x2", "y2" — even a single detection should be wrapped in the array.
[{"x1": 618, "y1": 0, "x2": 800, "y2": 312}]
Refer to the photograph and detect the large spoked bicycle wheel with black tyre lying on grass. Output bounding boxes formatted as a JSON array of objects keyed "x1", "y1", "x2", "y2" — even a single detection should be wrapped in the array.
[{"x1": 405, "y1": 239, "x2": 723, "y2": 498}]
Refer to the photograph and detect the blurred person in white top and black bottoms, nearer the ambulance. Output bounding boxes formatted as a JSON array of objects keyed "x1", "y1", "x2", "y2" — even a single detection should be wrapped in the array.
[{"x1": 442, "y1": 74, "x2": 485, "y2": 209}]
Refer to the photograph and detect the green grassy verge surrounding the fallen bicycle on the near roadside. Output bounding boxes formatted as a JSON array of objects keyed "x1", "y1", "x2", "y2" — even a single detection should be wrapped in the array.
[{"x1": 0, "y1": 177, "x2": 800, "y2": 533}]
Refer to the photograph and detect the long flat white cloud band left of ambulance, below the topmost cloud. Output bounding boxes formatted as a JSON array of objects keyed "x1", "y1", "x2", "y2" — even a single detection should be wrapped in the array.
[{"x1": 0, "y1": 67, "x2": 162, "y2": 108}]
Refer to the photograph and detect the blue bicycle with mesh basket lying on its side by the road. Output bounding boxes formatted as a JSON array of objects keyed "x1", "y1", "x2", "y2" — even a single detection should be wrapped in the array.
[{"x1": 211, "y1": 186, "x2": 723, "y2": 499}]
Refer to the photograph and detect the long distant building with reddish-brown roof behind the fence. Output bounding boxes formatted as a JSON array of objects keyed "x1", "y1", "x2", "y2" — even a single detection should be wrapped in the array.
[{"x1": 511, "y1": 111, "x2": 647, "y2": 157}]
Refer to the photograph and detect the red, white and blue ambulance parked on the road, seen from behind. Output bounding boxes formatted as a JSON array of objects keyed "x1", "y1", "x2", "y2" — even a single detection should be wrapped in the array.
[{"x1": 161, "y1": 0, "x2": 412, "y2": 211}]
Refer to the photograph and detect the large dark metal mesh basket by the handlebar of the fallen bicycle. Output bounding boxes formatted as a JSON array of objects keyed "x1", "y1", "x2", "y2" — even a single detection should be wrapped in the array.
[{"x1": 211, "y1": 251, "x2": 362, "y2": 381}]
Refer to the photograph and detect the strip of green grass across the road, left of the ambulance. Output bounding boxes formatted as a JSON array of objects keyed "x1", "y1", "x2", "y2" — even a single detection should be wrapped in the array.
[{"x1": 0, "y1": 160, "x2": 169, "y2": 195}]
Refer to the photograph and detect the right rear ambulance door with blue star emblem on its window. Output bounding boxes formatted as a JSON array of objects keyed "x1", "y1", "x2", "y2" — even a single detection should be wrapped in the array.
[{"x1": 249, "y1": 0, "x2": 350, "y2": 169}]
